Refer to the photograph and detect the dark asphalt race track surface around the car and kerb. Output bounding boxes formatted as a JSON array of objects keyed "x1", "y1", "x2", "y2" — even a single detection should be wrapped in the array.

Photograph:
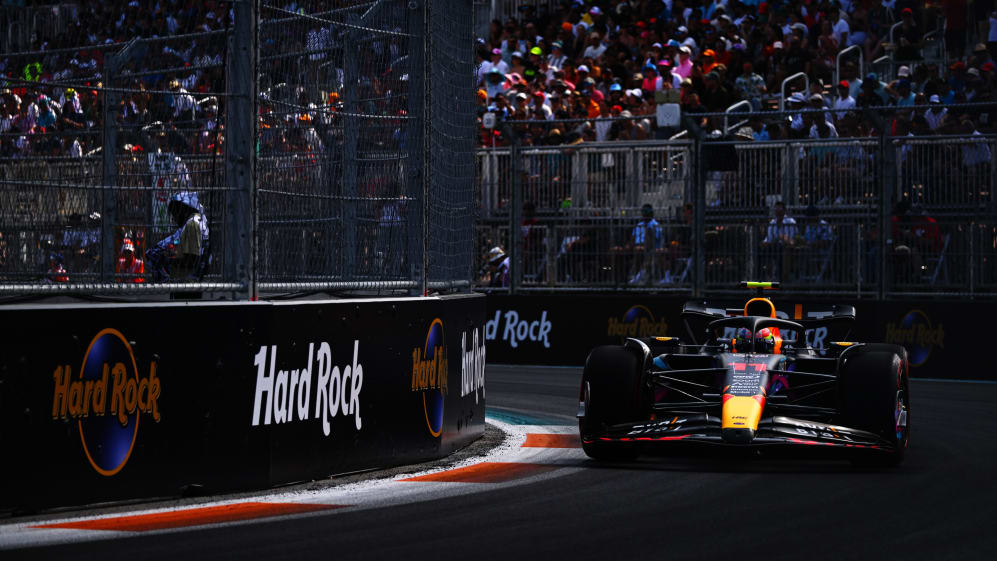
[{"x1": 7, "y1": 366, "x2": 997, "y2": 561}]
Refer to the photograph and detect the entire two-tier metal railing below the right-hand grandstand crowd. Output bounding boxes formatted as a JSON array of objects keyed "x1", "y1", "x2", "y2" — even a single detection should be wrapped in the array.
[{"x1": 476, "y1": 130, "x2": 997, "y2": 297}]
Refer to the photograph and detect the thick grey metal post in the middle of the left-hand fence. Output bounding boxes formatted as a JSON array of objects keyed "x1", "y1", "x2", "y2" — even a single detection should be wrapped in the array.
[{"x1": 223, "y1": 0, "x2": 259, "y2": 300}]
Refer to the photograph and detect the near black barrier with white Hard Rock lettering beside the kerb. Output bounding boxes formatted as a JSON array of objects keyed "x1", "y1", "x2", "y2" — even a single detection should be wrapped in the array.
[{"x1": 0, "y1": 295, "x2": 485, "y2": 508}]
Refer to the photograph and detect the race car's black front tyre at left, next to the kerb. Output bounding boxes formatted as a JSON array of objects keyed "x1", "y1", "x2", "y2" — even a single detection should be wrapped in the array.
[{"x1": 578, "y1": 345, "x2": 648, "y2": 460}]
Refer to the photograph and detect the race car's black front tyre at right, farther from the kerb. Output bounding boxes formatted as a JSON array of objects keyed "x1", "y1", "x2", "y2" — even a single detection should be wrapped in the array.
[{"x1": 838, "y1": 344, "x2": 910, "y2": 466}]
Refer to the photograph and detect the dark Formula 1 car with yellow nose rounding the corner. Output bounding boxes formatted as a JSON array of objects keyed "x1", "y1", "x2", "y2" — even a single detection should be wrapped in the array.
[{"x1": 578, "y1": 282, "x2": 910, "y2": 465}]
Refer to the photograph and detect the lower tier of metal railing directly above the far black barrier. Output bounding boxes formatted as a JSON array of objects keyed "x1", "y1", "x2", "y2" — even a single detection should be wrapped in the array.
[{"x1": 475, "y1": 214, "x2": 997, "y2": 298}]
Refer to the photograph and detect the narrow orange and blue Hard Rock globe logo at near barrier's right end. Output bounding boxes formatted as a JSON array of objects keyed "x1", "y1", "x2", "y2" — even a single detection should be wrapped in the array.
[{"x1": 412, "y1": 318, "x2": 450, "y2": 438}]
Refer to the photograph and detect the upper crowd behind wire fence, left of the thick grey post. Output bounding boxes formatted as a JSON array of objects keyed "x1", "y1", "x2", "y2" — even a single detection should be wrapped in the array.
[{"x1": 0, "y1": 0, "x2": 233, "y2": 158}]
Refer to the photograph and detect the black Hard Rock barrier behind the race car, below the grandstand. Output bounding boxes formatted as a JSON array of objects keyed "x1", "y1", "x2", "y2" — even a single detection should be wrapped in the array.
[{"x1": 485, "y1": 292, "x2": 984, "y2": 379}]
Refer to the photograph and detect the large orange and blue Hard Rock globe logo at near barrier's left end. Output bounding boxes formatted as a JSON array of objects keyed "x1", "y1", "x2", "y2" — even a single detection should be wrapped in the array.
[{"x1": 52, "y1": 328, "x2": 162, "y2": 477}]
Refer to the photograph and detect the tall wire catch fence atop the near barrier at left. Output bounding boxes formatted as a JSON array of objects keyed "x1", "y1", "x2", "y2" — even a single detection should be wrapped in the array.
[{"x1": 0, "y1": 0, "x2": 474, "y2": 296}]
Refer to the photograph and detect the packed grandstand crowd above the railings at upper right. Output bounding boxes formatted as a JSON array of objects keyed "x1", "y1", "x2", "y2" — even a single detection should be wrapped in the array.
[{"x1": 476, "y1": 0, "x2": 997, "y2": 146}]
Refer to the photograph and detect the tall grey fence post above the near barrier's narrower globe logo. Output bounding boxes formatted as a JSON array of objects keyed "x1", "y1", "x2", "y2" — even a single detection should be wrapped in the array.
[{"x1": 406, "y1": 1, "x2": 429, "y2": 296}]
